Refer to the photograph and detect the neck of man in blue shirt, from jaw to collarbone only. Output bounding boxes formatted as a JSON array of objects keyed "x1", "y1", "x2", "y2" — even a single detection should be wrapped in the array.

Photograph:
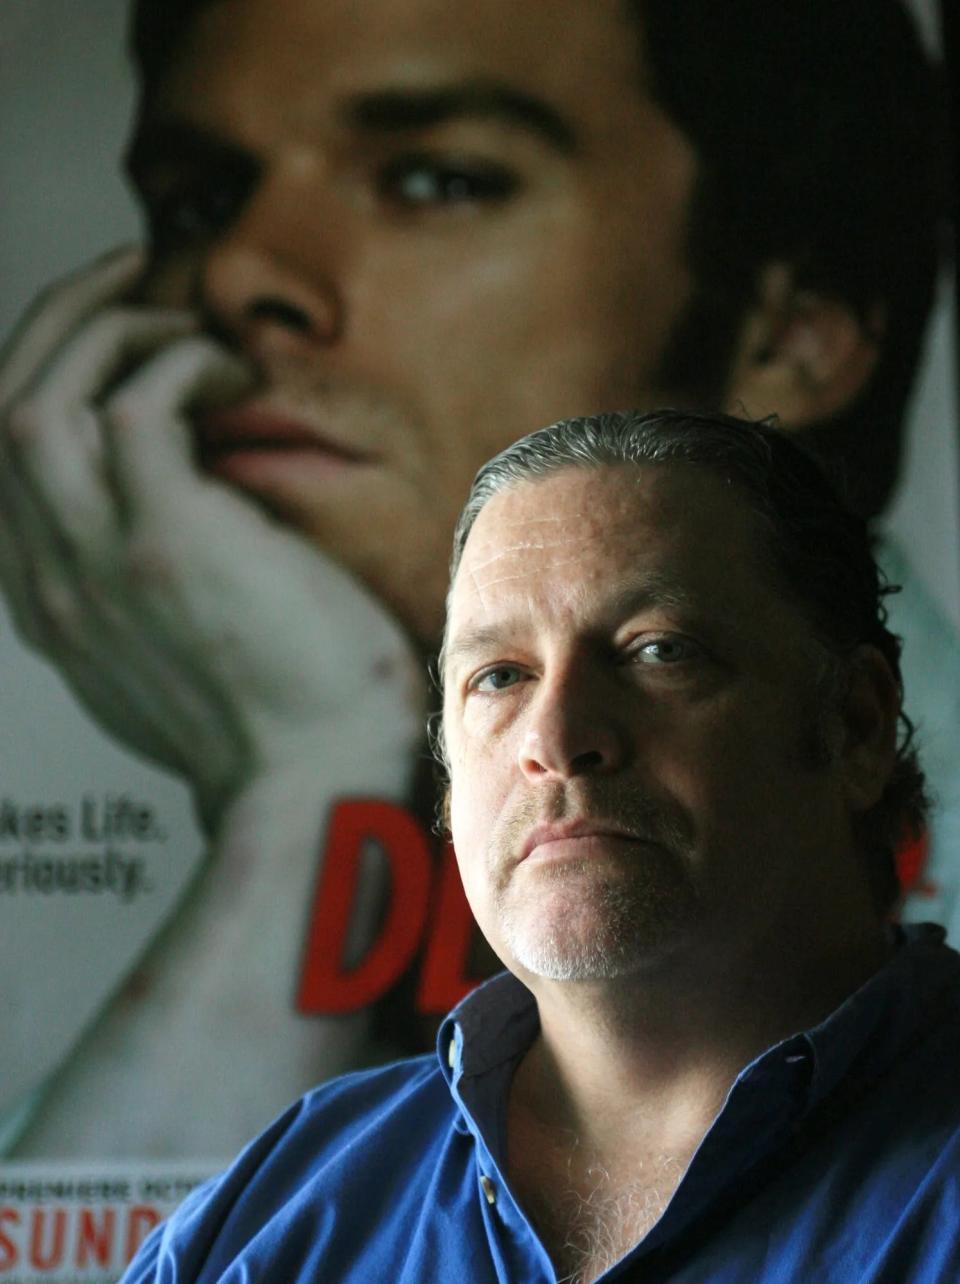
[{"x1": 517, "y1": 919, "x2": 889, "y2": 1135}]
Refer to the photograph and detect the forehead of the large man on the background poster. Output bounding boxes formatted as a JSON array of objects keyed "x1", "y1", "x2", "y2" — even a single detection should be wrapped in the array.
[{"x1": 140, "y1": 0, "x2": 643, "y2": 141}]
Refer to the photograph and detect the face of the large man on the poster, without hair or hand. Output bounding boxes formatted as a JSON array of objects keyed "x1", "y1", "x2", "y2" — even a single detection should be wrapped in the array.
[{"x1": 131, "y1": 0, "x2": 696, "y2": 641}]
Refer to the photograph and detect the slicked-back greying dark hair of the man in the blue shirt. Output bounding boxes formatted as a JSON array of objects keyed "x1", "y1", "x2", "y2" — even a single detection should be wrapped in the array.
[{"x1": 440, "y1": 410, "x2": 927, "y2": 913}]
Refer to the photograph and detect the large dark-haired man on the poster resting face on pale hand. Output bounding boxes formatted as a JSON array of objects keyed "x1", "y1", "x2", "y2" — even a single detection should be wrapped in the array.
[{"x1": 0, "y1": 0, "x2": 937, "y2": 1156}]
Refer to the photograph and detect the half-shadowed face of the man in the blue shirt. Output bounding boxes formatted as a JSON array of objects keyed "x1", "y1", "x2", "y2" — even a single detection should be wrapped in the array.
[{"x1": 444, "y1": 465, "x2": 855, "y2": 980}]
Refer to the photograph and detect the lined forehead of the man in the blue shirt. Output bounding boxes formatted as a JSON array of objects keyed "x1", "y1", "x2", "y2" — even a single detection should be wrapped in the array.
[{"x1": 444, "y1": 462, "x2": 812, "y2": 663}]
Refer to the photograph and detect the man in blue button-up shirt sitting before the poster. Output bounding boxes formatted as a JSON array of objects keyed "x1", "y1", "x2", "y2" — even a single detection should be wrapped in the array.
[{"x1": 120, "y1": 412, "x2": 960, "y2": 1284}]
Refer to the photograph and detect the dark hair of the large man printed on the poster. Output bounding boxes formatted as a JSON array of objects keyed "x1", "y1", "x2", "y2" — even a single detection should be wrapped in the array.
[{"x1": 131, "y1": 0, "x2": 950, "y2": 516}]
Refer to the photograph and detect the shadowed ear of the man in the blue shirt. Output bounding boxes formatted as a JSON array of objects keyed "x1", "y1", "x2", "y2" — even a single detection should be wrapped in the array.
[{"x1": 837, "y1": 645, "x2": 900, "y2": 811}]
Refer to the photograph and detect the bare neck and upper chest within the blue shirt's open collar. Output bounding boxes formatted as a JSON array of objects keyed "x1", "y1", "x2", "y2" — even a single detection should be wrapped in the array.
[{"x1": 507, "y1": 924, "x2": 888, "y2": 1279}]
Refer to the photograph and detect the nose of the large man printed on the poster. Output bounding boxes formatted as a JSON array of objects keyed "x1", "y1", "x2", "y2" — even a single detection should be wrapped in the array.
[{"x1": 198, "y1": 175, "x2": 344, "y2": 365}]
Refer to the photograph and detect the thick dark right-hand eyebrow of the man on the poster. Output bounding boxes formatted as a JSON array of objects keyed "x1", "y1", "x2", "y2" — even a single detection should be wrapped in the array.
[{"x1": 344, "y1": 80, "x2": 580, "y2": 154}]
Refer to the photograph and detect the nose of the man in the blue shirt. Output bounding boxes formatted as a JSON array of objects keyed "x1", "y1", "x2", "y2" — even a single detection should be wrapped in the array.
[{"x1": 519, "y1": 670, "x2": 630, "y2": 779}]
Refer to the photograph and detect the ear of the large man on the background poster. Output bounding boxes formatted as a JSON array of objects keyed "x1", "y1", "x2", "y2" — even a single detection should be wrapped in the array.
[{"x1": 726, "y1": 263, "x2": 883, "y2": 429}]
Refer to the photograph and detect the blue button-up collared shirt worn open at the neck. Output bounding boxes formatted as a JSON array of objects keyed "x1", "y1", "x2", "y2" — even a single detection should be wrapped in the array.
[{"x1": 124, "y1": 924, "x2": 960, "y2": 1284}]
